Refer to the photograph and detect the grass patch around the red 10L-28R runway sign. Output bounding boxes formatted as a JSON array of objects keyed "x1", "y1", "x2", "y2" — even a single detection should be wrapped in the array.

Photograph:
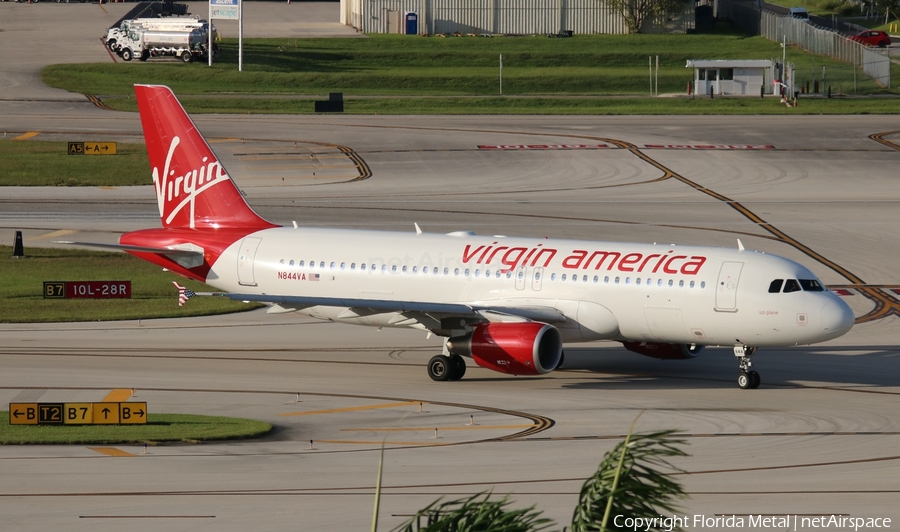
[{"x1": 0, "y1": 246, "x2": 257, "y2": 323}]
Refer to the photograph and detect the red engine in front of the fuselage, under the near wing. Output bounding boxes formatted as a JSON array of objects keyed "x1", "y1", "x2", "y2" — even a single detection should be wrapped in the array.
[{"x1": 447, "y1": 322, "x2": 562, "y2": 375}]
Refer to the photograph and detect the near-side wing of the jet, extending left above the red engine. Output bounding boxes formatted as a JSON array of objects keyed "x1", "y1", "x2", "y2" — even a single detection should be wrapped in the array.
[{"x1": 196, "y1": 292, "x2": 566, "y2": 323}]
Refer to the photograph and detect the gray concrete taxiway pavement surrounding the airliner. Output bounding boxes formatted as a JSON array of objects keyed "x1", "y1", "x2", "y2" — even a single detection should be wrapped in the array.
[{"x1": 0, "y1": 3, "x2": 900, "y2": 531}]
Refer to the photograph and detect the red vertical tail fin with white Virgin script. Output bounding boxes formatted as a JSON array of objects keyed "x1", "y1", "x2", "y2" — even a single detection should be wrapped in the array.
[{"x1": 134, "y1": 85, "x2": 275, "y2": 230}]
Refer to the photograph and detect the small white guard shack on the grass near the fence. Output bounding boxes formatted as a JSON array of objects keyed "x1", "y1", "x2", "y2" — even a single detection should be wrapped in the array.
[{"x1": 687, "y1": 59, "x2": 774, "y2": 96}]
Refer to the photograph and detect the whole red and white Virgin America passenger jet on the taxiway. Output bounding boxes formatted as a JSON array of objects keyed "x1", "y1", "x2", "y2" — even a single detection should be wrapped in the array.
[{"x1": 61, "y1": 85, "x2": 854, "y2": 388}]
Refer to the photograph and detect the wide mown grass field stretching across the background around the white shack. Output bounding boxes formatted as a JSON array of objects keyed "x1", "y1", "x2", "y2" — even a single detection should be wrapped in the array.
[{"x1": 43, "y1": 34, "x2": 900, "y2": 112}]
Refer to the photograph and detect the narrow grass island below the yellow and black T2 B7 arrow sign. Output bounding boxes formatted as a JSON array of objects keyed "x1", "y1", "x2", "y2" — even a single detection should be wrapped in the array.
[{"x1": 0, "y1": 412, "x2": 272, "y2": 445}]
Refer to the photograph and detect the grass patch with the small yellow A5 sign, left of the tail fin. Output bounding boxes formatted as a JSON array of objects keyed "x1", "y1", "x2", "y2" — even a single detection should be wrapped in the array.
[{"x1": 0, "y1": 139, "x2": 150, "y2": 186}]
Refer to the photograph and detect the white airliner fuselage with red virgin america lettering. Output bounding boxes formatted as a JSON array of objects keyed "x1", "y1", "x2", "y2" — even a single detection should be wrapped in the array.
[{"x1": 207, "y1": 227, "x2": 853, "y2": 346}]
